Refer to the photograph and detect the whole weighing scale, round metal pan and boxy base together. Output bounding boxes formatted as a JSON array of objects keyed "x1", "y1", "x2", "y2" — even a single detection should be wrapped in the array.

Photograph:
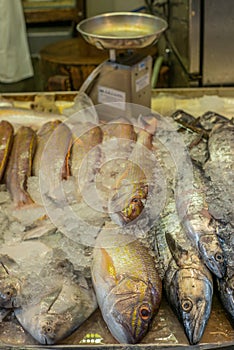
[{"x1": 77, "y1": 12, "x2": 167, "y2": 116}]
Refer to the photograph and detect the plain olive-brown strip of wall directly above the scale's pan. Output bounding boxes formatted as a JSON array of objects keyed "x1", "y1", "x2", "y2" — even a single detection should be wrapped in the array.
[{"x1": 86, "y1": 0, "x2": 144, "y2": 17}]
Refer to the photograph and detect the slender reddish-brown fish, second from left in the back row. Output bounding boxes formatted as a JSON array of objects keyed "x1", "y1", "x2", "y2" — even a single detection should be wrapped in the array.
[{"x1": 6, "y1": 126, "x2": 36, "y2": 209}]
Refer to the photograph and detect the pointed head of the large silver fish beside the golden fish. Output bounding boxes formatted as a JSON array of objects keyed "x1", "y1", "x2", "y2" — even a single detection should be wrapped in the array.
[{"x1": 168, "y1": 268, "x2": 213, "y2": 344}]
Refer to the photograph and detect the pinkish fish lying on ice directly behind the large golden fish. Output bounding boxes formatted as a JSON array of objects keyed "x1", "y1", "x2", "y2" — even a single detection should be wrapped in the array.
[{"x1": 109, "y1": 115, "x2": 157, "y2": 226}]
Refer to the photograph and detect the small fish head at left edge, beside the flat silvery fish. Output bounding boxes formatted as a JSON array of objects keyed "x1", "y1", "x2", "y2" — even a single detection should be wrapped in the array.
[{"x1": 0, "y1": 276, "x2": 21, "y2": 308}]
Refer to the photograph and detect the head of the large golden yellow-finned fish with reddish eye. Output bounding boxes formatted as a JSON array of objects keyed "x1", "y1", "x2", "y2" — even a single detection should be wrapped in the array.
[{"x1": 102, "y1": 277, "x2": 161, "y2": 344}]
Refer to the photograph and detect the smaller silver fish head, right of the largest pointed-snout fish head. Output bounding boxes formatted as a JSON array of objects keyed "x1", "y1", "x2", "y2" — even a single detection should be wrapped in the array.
[{"x1": 198, "y1": 234, "x2": 226, "y2": 278}]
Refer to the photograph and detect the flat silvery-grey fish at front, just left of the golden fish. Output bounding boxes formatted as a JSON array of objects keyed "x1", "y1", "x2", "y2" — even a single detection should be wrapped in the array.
[{"x1": 14, "y1": 251, "x2": 97, "y2": 345}]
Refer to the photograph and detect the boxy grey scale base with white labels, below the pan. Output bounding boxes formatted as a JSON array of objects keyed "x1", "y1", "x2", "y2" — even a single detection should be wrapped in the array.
[{"x1": 86, "y1": 55, "x2": 152, "y2": 120}]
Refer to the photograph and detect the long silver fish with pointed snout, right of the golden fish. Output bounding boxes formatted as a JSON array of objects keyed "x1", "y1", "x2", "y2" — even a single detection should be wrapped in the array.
[{"x1": 148, "y1": 128, "x2": 213, "y2": 344}]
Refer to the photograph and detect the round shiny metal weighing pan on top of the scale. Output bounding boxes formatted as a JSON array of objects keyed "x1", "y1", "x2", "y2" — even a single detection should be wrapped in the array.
[{"x1": 77, "y1": 12, "x2": 167, "y2": 50}]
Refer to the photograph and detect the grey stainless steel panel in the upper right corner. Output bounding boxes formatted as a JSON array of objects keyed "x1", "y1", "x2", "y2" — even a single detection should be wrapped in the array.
[{"x1": 202, "y1": 0, "x2": 234, "y2": 85}]
